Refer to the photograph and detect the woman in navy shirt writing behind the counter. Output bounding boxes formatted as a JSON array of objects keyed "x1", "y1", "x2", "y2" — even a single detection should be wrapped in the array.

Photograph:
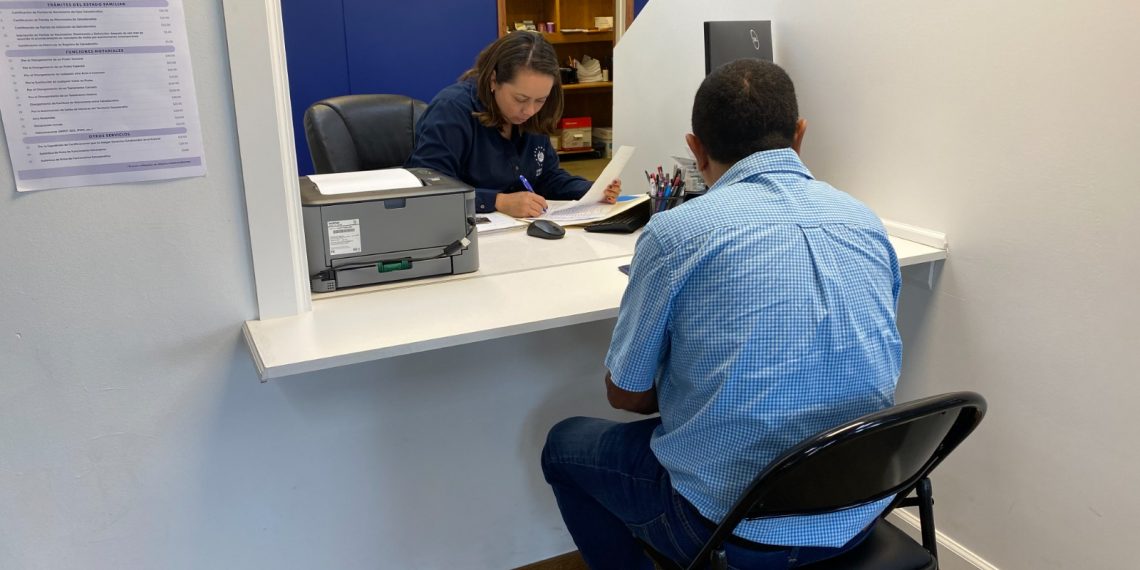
[{"x1": 407, "y1": 32, "x2": 621, "y2": 218}]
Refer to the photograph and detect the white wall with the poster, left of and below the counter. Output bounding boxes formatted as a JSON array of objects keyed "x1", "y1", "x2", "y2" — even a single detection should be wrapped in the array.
[{"x1": 0, "y1": 0, "x2": 633, "y2": 570}]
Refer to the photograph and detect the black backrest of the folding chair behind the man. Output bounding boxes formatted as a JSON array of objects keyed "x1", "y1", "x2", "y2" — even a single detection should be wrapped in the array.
[{"x1": 695, "y1": 392, "x2": 986, "y2": 560}]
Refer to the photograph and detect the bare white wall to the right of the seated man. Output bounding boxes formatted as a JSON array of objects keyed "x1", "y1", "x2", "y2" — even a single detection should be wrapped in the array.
[{"x1": 614, "y1": 0, "x2": 1140, "y2": 569}]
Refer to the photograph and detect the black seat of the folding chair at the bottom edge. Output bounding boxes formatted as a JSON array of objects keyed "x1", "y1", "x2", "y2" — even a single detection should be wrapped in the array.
[{"x1": 801, "y1": 521, "x2": 938, "y2": 570}]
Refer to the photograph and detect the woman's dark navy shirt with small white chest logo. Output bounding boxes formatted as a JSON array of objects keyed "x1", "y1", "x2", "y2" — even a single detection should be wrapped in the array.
[{"x1": 406, "y1": 81, "x2": 591, "y2": 212}]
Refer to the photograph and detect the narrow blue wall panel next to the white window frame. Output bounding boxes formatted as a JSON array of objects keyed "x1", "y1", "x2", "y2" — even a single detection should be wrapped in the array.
[{"x1": 282, "y1": 0, "x2": 349, "y2": 176}]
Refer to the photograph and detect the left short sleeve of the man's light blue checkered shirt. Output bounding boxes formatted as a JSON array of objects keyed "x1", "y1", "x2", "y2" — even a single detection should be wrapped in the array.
[{"x1": 605, "y1": 228, "x2": 675, "y2": 392}]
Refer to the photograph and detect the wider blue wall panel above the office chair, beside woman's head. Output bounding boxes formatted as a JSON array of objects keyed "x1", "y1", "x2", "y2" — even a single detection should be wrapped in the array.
[{"x1": 343, "y1": 0, "x2": 498, "y2": 101}]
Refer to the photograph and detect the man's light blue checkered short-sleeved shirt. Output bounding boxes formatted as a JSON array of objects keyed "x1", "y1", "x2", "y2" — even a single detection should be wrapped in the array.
[{"x1": 605, "y1": 149, "x2": 902, "y2": 546}]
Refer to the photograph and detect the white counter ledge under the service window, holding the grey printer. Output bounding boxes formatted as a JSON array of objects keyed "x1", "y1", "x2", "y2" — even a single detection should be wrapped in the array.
[{"x1": 243, "y1": 228, "x2": 946, "y2": 381}]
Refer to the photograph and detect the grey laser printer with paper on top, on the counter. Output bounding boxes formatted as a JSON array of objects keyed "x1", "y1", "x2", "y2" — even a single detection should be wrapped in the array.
[{"x1": 301, "y1": 169, "x2": 479, "y2": 293}]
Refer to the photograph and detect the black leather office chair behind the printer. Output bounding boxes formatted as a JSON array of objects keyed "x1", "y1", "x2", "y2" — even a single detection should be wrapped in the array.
[{"x1": 304, "y1": 95, "x2": 428, "y2": 174}]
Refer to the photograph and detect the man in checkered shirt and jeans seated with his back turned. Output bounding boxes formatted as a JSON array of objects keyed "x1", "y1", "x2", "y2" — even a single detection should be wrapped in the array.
[{"x1": 543, "y1": 60, "x2": 902, "y2": 570}]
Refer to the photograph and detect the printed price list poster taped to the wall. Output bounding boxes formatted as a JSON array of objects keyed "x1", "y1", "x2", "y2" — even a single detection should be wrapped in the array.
[{"x1": 0, "y1": 0, "x2": 205, "y2": 192}]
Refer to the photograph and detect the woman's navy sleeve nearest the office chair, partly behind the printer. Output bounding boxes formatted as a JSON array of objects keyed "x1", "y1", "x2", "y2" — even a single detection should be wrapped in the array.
[{"x1": 405, "y1": 100, "x2": 498, "y2": 212}]
